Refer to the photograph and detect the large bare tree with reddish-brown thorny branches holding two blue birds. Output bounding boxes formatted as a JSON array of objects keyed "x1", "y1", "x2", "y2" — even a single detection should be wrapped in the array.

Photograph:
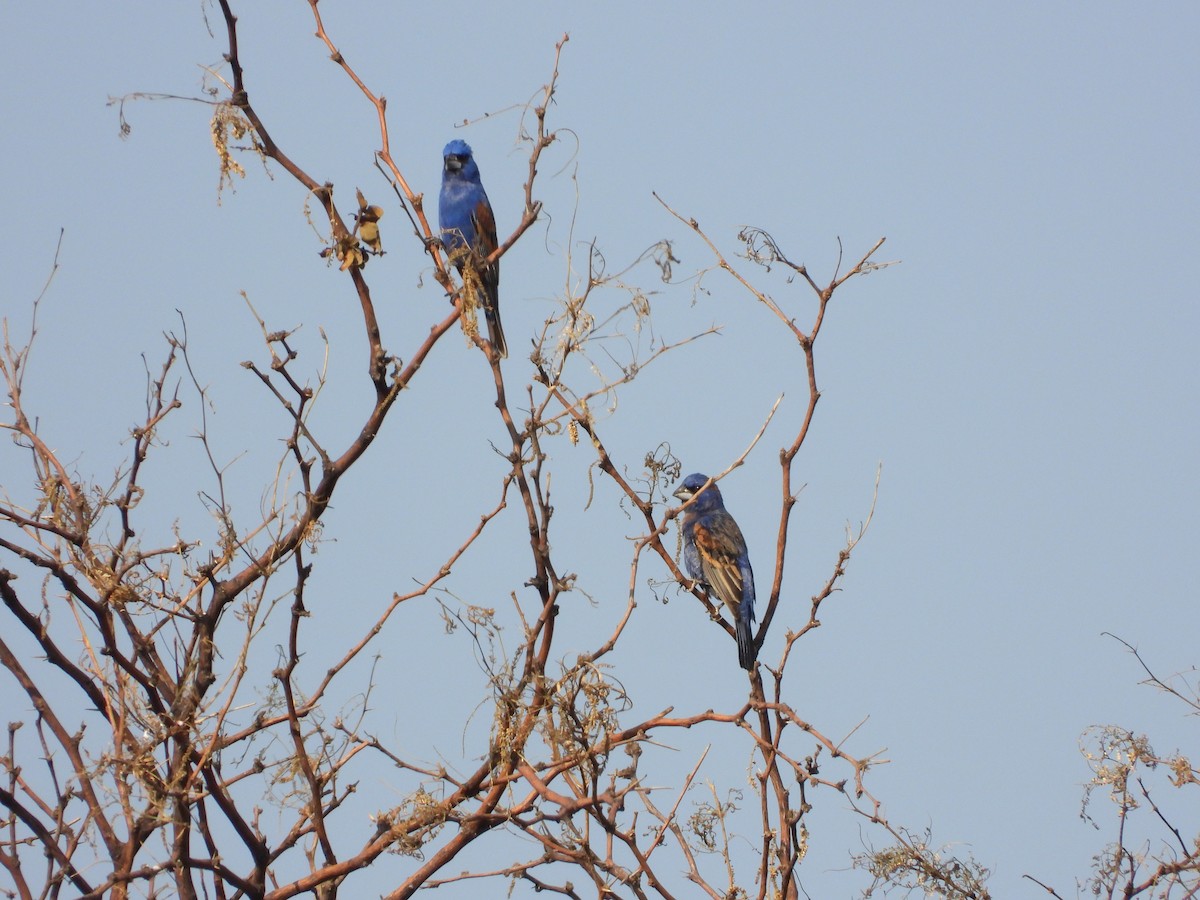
[{"x1": 0, "y1": 0, "x2": 1003, "y2": 898}]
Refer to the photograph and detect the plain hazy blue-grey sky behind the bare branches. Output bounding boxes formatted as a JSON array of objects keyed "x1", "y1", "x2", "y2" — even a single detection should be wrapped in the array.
[{"x1": 0, "y1": 0, "x2": 1200, "y2": 898}]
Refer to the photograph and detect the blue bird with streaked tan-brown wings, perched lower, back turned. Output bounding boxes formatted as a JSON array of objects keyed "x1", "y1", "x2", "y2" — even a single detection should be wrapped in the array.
[{"x1": 674, "y1": 472, "x2": 756, "y2": 671}]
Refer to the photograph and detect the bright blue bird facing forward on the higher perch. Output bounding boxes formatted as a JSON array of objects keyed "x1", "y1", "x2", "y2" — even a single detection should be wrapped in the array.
[{"x1": 438, "y1": 140, "x2": 509, "y2": 359}]
